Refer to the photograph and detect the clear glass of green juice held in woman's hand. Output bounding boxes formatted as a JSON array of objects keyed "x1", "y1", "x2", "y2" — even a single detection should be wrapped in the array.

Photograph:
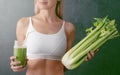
[{"x1": 13, "y1": 40, "x2": 27, "y2": 67}]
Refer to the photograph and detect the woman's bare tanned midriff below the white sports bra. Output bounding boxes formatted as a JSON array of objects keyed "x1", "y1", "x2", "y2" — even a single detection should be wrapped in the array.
[{"x1": 26, "y1": 59, "x2": 64, "y2": 75}]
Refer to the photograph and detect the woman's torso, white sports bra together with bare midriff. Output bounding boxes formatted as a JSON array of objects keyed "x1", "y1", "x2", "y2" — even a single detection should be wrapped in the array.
[{"x1": 25, "y1": 18, "x2": 66, "y2": 75}]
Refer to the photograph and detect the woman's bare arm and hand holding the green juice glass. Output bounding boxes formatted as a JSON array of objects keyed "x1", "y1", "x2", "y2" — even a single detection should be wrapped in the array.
[{"x1": 10, "y1": 18, "x2": 28, "y2": 72}]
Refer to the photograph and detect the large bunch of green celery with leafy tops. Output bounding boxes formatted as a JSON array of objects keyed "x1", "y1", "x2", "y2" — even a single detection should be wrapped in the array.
[{"x1": 62, "y1": 17, "x2": 119, "y2": 70}]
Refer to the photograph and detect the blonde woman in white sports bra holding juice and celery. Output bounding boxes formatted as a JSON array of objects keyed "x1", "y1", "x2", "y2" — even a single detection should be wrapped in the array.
[{"x1": 10, "y1": 0, "x2": 94, "y2": 75}]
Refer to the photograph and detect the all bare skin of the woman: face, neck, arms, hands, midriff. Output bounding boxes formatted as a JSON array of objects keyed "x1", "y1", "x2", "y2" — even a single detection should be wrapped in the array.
[{"x1": 10, "y1": 0, "x2": 95, "y2": 75}]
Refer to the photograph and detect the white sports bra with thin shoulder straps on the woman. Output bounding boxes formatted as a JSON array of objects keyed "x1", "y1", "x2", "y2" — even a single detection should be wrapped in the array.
[{"x1": 25, "y1": 17, "x2": 67, "y2": 60}]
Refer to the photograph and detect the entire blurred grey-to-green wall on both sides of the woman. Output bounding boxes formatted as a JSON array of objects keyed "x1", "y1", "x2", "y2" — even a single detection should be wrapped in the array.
[{"x1": 0, "y1": 0, "x2": 120, "y2": 75}]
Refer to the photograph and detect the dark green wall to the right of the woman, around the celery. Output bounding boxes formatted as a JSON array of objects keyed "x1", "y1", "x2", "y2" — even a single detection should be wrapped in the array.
[{"x1": 64, "y1": 0, "x2": 120, "y2": 75}]
